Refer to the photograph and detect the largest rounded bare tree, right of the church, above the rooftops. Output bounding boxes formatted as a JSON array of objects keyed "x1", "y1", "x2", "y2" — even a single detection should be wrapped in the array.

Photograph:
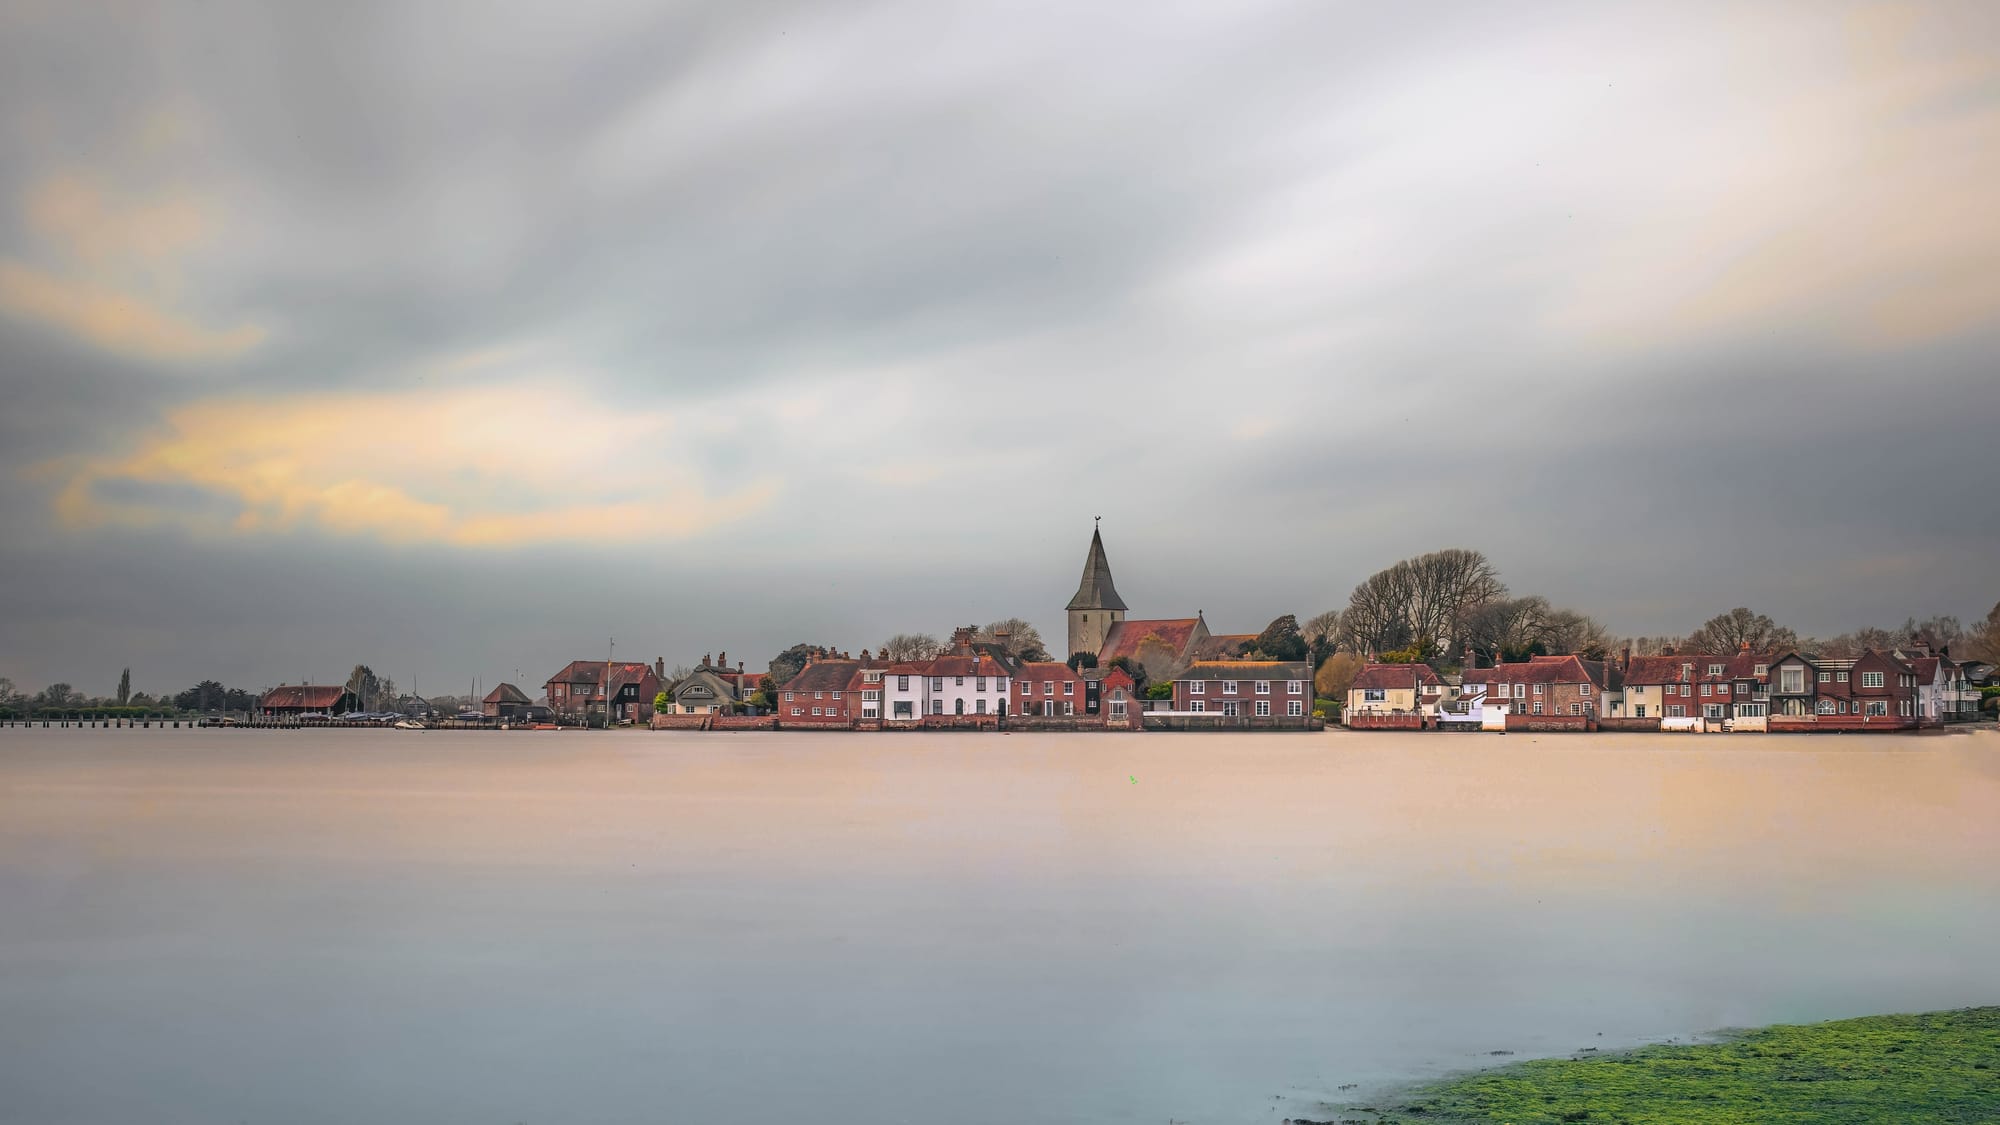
[{"x1": 1340, "y1": 546, "x2": 1506, "y2": 651}]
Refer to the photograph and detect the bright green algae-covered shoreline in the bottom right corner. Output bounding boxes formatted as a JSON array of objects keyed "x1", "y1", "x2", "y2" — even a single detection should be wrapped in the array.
[{"x1": 1292, "y1": 1007, "x2": 2000, "y2": 1125}]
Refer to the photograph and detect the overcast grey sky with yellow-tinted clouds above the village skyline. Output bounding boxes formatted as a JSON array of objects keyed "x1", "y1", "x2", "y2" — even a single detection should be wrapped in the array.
[{"x1": 0, "y1": 0, "x2": 2000, "y2": 693}]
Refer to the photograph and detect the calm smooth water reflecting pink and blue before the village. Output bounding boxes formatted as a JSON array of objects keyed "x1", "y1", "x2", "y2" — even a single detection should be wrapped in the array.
[{"x1": 0, "y1": 729, "x2": 2000, "y2": 1125}]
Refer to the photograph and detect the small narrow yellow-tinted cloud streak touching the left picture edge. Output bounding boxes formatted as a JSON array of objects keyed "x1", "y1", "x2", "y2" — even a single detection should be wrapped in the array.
[{"x1": 0, "y1": 262, "x2": 264, "y2": 360}]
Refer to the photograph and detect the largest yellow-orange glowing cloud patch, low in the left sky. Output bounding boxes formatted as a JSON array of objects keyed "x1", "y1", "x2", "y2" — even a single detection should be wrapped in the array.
[{"x1": 52, "y1": 382, "x2": 776, "y2": 546}]
